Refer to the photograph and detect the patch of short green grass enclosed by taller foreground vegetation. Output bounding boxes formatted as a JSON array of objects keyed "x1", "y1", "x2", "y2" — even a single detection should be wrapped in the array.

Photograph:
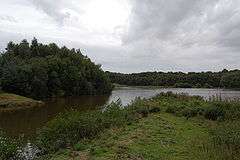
[{"x1": 52, "y1": 113, "x2": 210, "y2": 160}]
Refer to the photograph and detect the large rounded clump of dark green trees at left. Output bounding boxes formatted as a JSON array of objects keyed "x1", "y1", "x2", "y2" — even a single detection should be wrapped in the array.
[{"x1": 0, "y1": 38, "x2": 112, "y2": 99}]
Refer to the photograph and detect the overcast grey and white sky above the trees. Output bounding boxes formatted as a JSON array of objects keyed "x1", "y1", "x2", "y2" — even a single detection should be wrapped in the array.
[{"x1": 0, "y1": 0, "x2": 240, "y2": 73}]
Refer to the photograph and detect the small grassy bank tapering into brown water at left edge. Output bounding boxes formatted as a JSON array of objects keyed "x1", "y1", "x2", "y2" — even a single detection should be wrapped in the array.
[{"x1": 0, "y1": 93, "x2": 43, "y2": 112}]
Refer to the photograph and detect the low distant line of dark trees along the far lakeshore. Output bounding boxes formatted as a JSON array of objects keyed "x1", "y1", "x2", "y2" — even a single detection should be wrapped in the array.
[{"x1": 107, "y1": 69, "x2": 240, "y2": 88}]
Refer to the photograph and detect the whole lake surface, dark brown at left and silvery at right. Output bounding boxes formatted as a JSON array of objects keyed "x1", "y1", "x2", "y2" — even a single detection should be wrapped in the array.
[{"x1": 0, "y1": 87, "x2": 240, "y2": 136}]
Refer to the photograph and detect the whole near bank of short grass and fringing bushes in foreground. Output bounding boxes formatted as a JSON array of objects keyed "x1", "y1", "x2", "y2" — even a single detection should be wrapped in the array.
[{"x1": 0, "y1": 92, "x2": 240, "y2": 160}]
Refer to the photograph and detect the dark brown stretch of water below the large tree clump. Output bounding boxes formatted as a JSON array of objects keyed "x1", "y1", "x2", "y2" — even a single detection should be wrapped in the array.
[{"x1": 0, "y1": 96, "x2": 109, "y2": 136}]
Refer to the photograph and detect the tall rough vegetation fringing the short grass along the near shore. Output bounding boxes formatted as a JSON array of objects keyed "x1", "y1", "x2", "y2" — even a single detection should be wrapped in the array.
[{"x1": 0, "y1": 92, "x2": 240, "y2": 160}]
